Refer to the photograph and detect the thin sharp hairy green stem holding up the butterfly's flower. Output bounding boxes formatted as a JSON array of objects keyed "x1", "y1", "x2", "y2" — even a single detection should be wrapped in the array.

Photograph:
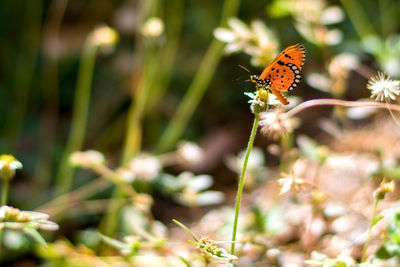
[{"x1": 231, "y1": 113, "x2": 260, "y2": 255}]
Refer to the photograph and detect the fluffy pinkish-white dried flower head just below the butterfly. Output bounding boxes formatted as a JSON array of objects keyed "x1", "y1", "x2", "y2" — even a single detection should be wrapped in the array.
[{"x1": 259, "y1": 108, "x2": 293, "y2": 138}]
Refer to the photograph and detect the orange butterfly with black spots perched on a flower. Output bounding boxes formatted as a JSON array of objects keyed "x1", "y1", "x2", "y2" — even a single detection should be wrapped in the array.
[{"x1": 250, "y1": 44, "x2": 306, "y2": 105}]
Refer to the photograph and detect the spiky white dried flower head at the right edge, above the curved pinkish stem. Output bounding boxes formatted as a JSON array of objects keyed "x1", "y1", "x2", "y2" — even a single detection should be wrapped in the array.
[{"x1": 367, "y1": 72, "x2": 400, "y2": 101}]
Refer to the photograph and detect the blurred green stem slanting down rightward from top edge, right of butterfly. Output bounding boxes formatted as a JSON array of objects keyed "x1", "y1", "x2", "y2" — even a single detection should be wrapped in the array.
[{"x1": 341, "y1": 0, "x2": 377, "y2": 38}]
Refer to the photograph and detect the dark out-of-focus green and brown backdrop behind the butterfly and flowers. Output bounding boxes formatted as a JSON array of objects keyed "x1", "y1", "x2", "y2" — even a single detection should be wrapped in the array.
[{"x1": 0, "y1": 0, "x2": 400, "y2": 264}]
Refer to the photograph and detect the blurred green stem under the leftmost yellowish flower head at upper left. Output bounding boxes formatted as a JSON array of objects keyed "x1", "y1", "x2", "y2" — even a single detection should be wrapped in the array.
[{"x1": 56, "y1": 39, "x2": 99, "y2": 196}]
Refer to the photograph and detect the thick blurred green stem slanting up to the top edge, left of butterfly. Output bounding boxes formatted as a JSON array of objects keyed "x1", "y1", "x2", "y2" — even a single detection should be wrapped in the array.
[{"x1": 156, "y1": 0, "x2": 240, "y2": 152}]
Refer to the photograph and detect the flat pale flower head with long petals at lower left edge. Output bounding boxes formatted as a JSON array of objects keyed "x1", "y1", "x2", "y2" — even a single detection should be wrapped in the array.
[{"x1": 0, "y1": 206, "x2": 58, "y2": 231}]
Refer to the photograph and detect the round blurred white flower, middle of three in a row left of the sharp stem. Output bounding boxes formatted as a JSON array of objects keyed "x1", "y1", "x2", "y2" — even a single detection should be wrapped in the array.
[{"x1": 129, "y1": 154, "x2": 162, "y2": 180}]
